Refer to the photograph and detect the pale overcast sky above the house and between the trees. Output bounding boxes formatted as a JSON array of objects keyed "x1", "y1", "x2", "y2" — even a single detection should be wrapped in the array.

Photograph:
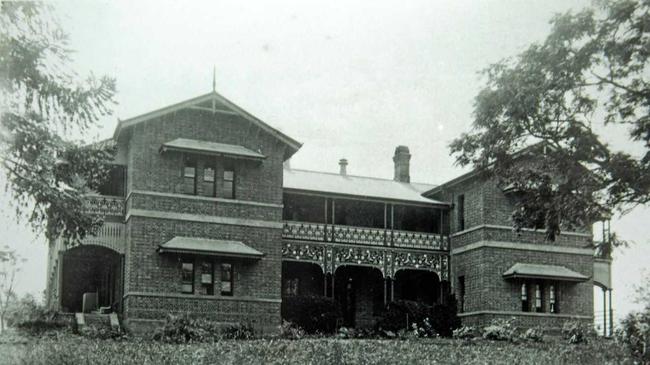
[{"x1": 0, "y1": 0, "x2": 650, "y2": 324}]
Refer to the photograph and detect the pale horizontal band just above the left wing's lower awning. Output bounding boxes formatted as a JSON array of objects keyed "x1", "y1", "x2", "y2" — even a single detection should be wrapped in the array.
[{"x1": 124, "y1": 209, "x2": 283, "y2": 229}]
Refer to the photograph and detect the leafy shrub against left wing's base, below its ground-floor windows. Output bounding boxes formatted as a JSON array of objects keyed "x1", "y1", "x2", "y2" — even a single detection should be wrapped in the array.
[{"x1": 153, "y1": 314, "x2": 219, "y2": 343}]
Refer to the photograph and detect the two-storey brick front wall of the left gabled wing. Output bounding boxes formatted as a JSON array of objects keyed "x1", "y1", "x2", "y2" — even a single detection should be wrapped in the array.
[{"x1": 120, "y1": 109, "x2": 285, "y2": 330}]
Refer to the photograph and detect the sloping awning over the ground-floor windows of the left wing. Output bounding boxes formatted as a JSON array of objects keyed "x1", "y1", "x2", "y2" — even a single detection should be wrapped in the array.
[{"x1": 158, "y1": 237, "x2": 264, "y2": 259}]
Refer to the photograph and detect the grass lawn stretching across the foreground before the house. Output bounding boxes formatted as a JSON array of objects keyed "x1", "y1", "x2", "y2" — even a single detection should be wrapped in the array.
[{"x1": 0, "y1": 334, "x2": 634, "y2": 365}]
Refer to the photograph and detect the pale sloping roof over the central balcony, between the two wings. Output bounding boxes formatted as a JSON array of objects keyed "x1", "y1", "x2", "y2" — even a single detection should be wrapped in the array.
[{"x1": 282, "y1": 168, "x2": 449, "y2": 206}]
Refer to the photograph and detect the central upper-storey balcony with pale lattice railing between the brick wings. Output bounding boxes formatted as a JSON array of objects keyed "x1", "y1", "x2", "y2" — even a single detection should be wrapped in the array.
[{"x1": 282, "y1": 192, "x2": 449, "y2": 251}]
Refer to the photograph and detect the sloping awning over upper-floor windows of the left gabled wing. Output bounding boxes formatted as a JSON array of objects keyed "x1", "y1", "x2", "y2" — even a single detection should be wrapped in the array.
[{"x1": 160, "y1": 138, "x2": 266, "y2": 160}]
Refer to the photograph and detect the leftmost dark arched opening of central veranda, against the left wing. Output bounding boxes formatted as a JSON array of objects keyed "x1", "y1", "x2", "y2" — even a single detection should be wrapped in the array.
[{"x1": 282, "y1": 261, "x2": 325, "y2": 297}]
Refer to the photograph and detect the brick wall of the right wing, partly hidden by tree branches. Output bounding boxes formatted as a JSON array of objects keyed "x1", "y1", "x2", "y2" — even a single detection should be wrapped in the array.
[{"x1": 435, "y1": 171, "x2": 594, "y2": 327}]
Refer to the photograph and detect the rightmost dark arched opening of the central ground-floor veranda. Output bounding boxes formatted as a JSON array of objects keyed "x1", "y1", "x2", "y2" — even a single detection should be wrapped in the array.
[{"x1": 394, "y1": 269, "x2": 442, "y2": 305}]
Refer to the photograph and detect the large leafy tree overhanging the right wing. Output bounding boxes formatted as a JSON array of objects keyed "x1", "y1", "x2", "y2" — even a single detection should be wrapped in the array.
[{"x1": 450, "y1": 0, "x2": 650, "y2": 239}]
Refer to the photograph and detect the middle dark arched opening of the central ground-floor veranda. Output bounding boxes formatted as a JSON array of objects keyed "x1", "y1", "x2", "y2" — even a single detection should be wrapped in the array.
[{"x1": 334, "y1": 266, "x2": 385, "y2": 328}]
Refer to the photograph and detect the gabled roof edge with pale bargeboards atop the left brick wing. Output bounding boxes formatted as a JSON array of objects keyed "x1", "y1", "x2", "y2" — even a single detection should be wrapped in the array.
[{"x1": 113, "y1": 91, "x2": 302, "y2": 157}]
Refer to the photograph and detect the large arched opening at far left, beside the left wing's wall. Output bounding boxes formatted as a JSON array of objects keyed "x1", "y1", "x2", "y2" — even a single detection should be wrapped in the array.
[{"x1": 60, "y1": 245, "x2": 122, "y2": 312}]
